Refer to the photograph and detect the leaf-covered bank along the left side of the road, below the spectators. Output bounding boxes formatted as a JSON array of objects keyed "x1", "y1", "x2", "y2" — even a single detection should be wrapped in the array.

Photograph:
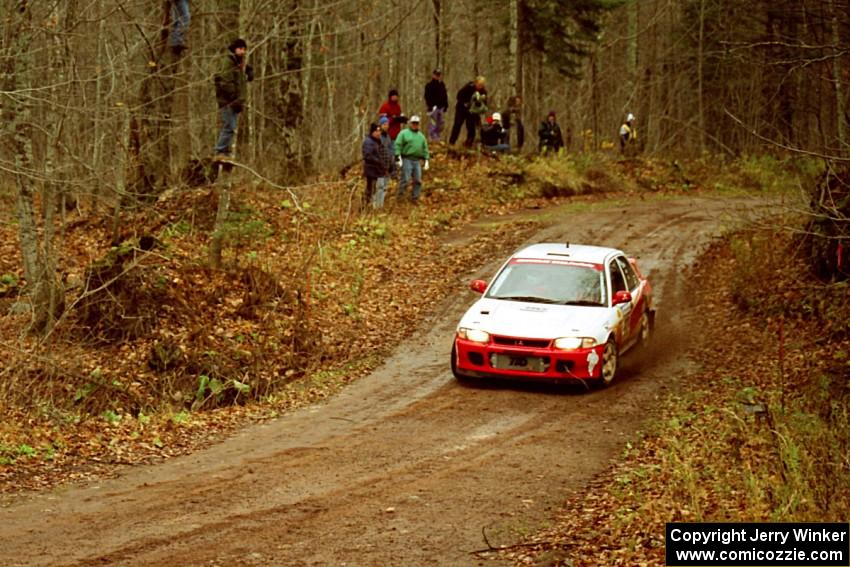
[{"x1": 0, "y1": 151, "x2": 808, "y2": 492}]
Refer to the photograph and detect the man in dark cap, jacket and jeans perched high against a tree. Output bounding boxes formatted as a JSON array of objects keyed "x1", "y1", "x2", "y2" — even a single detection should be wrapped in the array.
[{"x1": 213, "y1": 38, "x2": 249, "y2": 159}]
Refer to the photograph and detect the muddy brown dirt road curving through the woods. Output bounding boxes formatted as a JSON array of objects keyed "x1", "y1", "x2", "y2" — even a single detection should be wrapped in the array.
[{"x1": 0, "y1": 194, "x2": 768, "y2": 566}]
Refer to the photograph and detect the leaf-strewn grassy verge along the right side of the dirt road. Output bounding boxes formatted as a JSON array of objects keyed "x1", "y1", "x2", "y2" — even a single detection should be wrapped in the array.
[{"x1": 505, "y1": 217, "x2": 850, "y2": 566}]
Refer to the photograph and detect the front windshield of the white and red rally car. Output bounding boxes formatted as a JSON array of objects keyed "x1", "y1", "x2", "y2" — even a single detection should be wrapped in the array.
[{"x1": 487, "y1": 262, "x2": 606, "y2": 306}]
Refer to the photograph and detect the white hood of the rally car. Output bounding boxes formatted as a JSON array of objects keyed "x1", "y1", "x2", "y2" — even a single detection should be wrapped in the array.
[{"x1": 460, "y1": 298, "x2": 612, "y2": 341}]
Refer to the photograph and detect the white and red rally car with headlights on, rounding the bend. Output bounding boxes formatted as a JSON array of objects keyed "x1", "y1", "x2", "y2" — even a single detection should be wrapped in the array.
[{"x1": 451, "y1": 243, "x2": 655, "y2": 386}]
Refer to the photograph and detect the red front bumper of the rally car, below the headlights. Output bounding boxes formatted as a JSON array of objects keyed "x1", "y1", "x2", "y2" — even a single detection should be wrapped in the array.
[{"x1": 454, "y1": 337, "x2": 603, "y2": 381}]
